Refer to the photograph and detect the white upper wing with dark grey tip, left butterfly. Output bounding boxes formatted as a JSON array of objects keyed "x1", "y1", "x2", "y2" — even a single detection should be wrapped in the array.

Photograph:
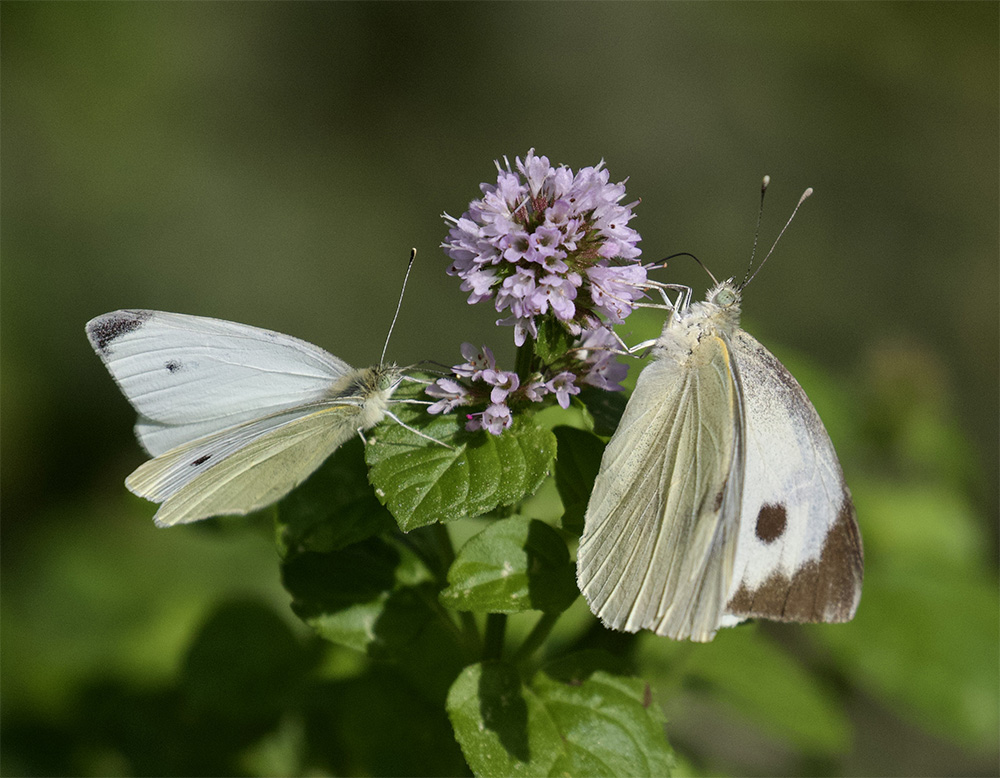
[{"x1": 87, "y1": 310, "x2": 352, "y2": 456}]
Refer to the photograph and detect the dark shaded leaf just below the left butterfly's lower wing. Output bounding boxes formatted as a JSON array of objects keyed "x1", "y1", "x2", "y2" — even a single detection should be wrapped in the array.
[{"x1": 277, "y1": 438, "x2": 395, "y2": 557}]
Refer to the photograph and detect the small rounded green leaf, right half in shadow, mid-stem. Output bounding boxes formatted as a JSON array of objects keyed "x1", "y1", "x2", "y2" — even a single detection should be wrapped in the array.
[{"x1": 441, "y1": 516, "x2": 578, "y2": 613}]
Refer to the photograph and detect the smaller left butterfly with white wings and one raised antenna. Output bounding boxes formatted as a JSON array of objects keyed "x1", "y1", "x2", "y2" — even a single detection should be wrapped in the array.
[{"x1": 86, "y1": 251, "x2": 427, "y2": 527}]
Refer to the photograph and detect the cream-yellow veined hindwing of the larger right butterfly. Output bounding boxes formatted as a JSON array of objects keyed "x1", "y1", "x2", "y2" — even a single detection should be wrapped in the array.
[{"x1": 577, "y1": 334, "x2": 742, "y2": 641}]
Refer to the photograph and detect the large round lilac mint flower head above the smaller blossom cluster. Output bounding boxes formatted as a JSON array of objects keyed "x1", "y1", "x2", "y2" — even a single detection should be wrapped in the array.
[{"x1": 441, "y1": 149, "x2": 646, "y2": 346}]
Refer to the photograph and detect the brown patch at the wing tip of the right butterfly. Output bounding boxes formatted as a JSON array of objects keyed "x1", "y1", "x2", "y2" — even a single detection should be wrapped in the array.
[{"x1": 726, "y1": 494, "x2": 864, "y2": 622}]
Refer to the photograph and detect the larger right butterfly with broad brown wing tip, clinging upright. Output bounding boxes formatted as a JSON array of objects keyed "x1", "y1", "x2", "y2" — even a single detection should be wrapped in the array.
[{"x1": 577, "y1": 183, "x2": 863, "y2": 642}]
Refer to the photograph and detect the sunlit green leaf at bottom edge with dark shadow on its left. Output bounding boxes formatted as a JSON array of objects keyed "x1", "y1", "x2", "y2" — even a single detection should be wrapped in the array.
[{"x1": 447, "y1": 662, "x2": 673, "y2": 778}]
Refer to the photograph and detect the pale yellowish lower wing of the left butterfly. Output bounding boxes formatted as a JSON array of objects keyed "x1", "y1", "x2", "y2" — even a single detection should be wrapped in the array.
[{"x1": 125, "y1": 403, "x2": 365, "y2": 527}]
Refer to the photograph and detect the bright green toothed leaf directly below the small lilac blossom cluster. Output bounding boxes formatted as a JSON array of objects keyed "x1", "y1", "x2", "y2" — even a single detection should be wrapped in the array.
[{"x1": 366, "y1": 387, "x2": 556, "y2": 532}]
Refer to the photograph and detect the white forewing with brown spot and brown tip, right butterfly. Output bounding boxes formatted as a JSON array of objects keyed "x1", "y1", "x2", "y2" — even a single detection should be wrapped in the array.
[{"x1": 724, "y1": 330, "x2": 863, "y2": 625}]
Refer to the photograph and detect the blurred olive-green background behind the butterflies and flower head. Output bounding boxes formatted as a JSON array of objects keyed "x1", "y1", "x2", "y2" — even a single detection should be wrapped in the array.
[{"x1": 0, "y1": 2, "x2": 1000, "y2": 775}]
